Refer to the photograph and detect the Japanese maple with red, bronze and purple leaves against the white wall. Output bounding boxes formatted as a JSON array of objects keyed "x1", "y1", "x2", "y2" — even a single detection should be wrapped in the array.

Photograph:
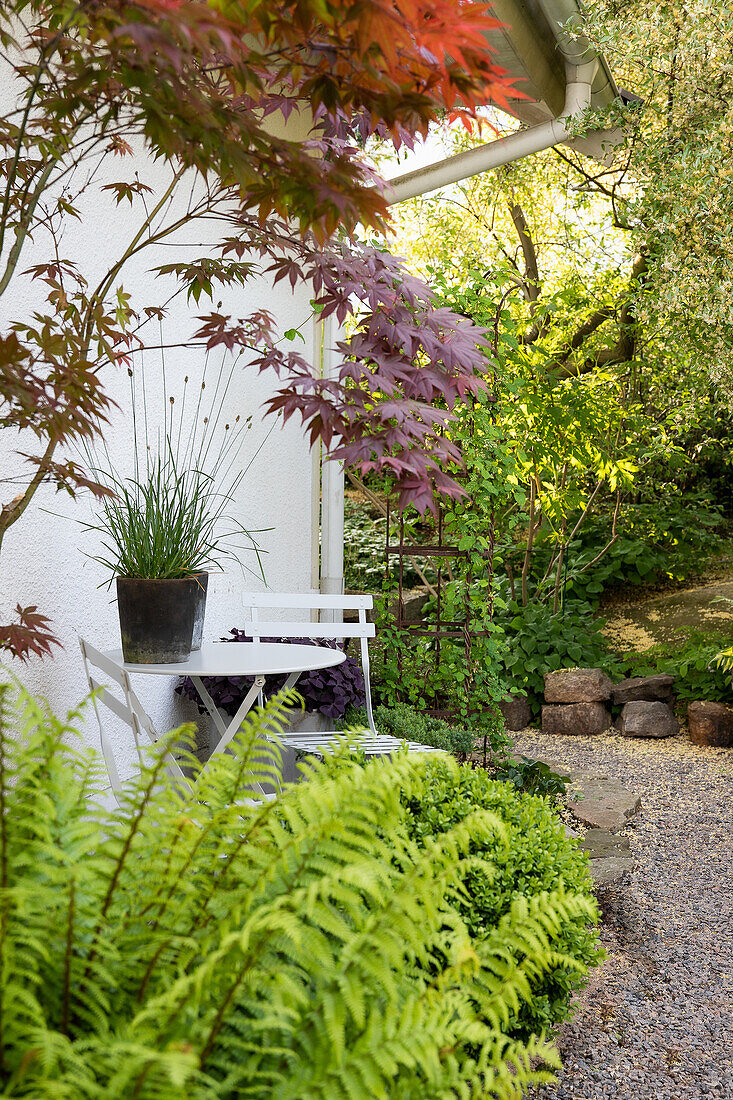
[{"x1": 0, "y1": 0, "x2": 508, "y2": 658}]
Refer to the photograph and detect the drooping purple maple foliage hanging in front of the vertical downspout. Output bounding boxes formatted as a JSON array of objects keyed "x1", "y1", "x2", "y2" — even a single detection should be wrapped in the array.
[{"x1": 191, "y1": 226, "x2": 488, "y2": 513}]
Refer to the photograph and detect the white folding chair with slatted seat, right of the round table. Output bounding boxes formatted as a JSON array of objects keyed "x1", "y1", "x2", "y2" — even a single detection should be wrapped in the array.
[{"x1": 242, "y1": 592, "x2": 440, "y2": 757}]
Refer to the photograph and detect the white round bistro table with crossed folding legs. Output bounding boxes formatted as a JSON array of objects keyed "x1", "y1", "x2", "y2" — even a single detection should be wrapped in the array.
[{"x1": 105, "y1": 641, "x2": 346, "y2": 755}]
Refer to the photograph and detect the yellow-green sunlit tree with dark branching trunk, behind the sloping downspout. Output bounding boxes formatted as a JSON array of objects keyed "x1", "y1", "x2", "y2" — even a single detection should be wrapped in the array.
[{"x1": 378, "y1": 65, "x2": 726, "y2": 609}]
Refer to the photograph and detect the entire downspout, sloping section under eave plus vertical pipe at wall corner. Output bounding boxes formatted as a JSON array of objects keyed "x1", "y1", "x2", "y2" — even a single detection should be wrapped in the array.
[{"x1": 320, "y1": 59, "x2": 599, "y2": 595}]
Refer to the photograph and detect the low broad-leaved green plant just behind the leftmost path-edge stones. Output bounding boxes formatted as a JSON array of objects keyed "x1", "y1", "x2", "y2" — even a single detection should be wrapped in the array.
[{"x1": 502, "y1": 601, "x2": 619, "y2": 713}]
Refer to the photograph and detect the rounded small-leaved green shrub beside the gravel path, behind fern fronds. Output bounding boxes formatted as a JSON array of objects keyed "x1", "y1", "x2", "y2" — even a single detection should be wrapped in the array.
[{"x1": 406, "y1": 757, "x2": 600, "y2": 1040}]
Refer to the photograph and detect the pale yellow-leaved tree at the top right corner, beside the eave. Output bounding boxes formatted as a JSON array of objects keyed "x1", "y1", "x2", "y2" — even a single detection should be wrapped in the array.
[{"x1": 588, "y1": 0, "x2": 733, "y2": 388}]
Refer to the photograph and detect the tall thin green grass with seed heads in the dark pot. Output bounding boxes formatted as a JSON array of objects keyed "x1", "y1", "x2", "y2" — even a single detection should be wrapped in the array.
[{"x1": 84, "y1": 356, "x2": 264, "y2": 580}]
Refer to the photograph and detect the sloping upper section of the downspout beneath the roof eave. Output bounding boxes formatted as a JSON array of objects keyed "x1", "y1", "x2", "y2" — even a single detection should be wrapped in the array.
[{"x1": 385, "y1": 59, "x2": 598, "y2": 206}]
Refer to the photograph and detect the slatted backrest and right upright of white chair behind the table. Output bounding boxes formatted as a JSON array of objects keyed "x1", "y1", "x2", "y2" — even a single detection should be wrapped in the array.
[{"x1": 242, "y1": 592, "x2": 376, "y2": 734}]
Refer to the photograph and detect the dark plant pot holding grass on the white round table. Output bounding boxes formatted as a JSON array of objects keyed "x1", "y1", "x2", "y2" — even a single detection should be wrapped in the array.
[{"x1": 117, "y1": 576, "x2": 203, "y2": 664}]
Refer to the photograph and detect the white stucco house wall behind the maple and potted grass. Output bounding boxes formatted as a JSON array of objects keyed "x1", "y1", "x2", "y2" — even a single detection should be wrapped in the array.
[{"x1": 0, "y1": 90, "x2": 317, "y2": 770}]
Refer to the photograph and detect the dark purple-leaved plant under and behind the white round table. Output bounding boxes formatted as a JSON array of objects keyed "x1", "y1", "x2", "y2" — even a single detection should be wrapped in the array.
[{"x1": 176, "y1": 627, "x2": 365, "y2": 721}]
